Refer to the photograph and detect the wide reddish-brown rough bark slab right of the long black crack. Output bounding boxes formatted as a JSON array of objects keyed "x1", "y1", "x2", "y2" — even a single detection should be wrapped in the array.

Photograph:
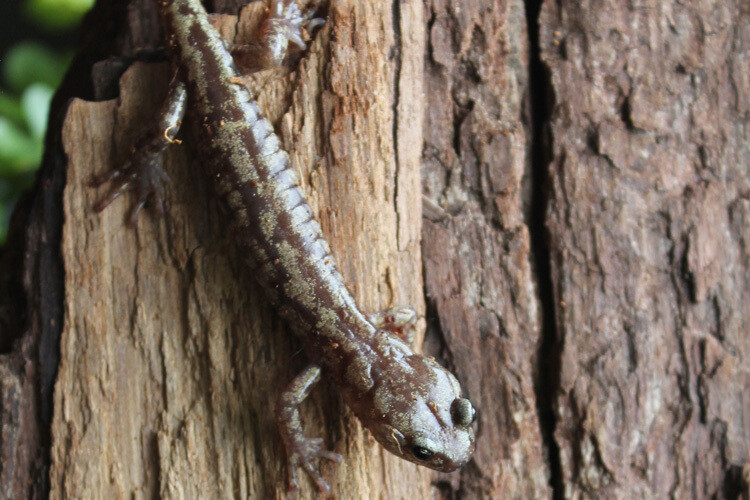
[{"x1": 540, "y1": 0, "x2": 750, "y2": 498}]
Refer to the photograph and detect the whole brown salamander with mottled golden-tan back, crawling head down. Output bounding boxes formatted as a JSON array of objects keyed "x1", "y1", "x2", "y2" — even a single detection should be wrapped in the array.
[{"x1": 97, "y1": 0, "x2": 475, "y2": 491}]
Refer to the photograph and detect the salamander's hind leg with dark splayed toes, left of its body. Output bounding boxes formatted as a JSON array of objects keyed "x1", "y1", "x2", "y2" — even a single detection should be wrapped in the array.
[{"x1": 92, "y1": 73, "x2": 186, "y2": 224}]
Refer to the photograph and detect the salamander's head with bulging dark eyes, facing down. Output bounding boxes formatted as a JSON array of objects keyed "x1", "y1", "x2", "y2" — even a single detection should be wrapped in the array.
[{"x1": 362, "y1": 354, "x2": 476, "y2": 472}]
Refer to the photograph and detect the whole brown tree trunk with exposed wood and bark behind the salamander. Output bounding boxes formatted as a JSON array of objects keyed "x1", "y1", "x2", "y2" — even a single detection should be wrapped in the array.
[{"x1": 0, "y1": 0, "x2": 750, "y2": 498}]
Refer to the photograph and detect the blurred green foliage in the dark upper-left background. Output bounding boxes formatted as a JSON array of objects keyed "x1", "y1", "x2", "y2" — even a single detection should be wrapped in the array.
[{"x1": 0, "y1": 0, "x2": 94, "y2": 243}]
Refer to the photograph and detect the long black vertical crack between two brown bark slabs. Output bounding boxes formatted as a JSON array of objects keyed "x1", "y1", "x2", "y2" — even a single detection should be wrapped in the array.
[{"x1": 524, "y1": 0, "x2": 563, "y2": 499}]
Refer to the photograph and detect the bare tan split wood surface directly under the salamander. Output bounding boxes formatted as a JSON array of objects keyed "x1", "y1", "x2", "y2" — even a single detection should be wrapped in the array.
[{"x1": 50, "y1": 2, "x2": 430, "y2": 498}]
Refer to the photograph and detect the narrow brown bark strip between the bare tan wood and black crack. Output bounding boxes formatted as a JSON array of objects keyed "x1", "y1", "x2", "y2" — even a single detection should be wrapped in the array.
[{"x1": 422, "y1": 0, "x2": 550, "y2": 498}]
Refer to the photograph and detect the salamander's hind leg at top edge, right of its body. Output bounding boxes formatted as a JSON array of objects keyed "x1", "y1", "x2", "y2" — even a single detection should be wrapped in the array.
[{"x1": 230, "y1": 0, "x2": 325, "y2": 72}]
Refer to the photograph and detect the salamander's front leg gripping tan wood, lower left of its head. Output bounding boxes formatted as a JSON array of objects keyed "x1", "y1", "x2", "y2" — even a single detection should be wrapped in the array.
[{"x1": 276, "y1": 365, "x2": 341, "y2": 492}]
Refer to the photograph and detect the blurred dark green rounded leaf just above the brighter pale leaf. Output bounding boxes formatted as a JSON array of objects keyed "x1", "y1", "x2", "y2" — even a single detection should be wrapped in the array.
[{"x1": 3, "y1": 42, "x2": 70, "y2": 93}]
